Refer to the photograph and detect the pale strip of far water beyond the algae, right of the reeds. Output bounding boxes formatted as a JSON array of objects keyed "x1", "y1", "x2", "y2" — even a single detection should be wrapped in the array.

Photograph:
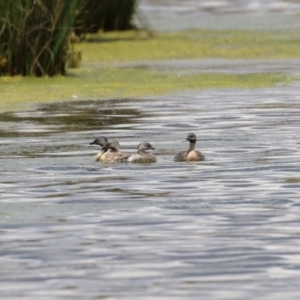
[{"x1": 137, "y1": 0, "x2": 300, "y2": 31}]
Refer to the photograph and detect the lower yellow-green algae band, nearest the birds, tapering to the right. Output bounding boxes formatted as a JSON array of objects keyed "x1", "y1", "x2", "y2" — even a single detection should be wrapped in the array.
[{"x1": 0, "y1": 68, "x2": 289, "y2": 111}]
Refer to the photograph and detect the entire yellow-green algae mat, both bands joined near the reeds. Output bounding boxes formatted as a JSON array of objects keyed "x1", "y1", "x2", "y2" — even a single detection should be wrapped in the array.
[{"x1": 0, "y1": 30, "x2": 300, "y2": 112}]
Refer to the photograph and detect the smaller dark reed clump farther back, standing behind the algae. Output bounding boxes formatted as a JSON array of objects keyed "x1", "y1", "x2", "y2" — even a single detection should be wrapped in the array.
[{"x1": 76, "y1": 0, "x2": 137, "y2": 35}]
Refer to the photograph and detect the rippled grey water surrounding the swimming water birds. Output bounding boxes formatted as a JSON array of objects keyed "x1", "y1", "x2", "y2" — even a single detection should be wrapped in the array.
[{"x1": 0, "y1": 87, "x2": 300, "y2": 299}]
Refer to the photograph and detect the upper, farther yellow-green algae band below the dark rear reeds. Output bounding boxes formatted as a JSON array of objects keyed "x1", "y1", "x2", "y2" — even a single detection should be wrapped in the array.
[{"x1": 80, "y1": 30, "x2": 300, "y2": 62}]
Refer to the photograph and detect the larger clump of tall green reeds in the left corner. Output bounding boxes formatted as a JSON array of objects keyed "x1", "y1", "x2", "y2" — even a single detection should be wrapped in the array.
[{"x1": 0, "y1": 0, "x2": 82, "y2": 76}]
